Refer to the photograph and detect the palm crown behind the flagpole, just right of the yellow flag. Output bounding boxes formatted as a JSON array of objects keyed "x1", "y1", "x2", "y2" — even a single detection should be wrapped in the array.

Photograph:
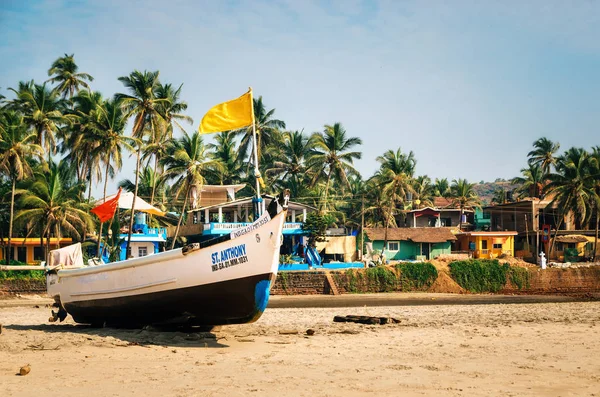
[{"x1": 235, "y1": 96, "x2": 285, "y2": 161}]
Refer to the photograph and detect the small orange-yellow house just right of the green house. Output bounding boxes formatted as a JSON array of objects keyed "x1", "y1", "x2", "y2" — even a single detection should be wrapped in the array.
[{"x1": 456, "y1": 231, "x2": 518, "y2": 259}]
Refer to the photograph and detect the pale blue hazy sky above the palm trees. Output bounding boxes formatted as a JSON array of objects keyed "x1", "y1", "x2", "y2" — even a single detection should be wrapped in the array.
[{"x1": 0, "y1": 0, "x2": 600, "y2": 196}]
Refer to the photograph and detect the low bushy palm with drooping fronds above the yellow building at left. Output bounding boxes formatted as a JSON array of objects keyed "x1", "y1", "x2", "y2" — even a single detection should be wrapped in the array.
[{"x1": 15, "y1": 161, "x2": 93, "y2": 261}]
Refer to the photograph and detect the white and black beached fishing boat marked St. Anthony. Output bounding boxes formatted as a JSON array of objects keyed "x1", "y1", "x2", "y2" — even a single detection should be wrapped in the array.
[{"x1": 47, "y1": 193, "x2": 289, "y2": 326}]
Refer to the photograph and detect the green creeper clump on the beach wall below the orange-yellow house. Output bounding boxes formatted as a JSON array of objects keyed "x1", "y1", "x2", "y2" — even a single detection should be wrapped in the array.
[{"x1": 450, "y1": 259, "x2": 510, "y2": 292}]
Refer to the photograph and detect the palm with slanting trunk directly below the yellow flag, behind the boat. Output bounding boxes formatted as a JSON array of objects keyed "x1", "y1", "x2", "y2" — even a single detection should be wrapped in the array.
[{"x1": 164, "y1": 131, "x2": 222, "y2": 249}]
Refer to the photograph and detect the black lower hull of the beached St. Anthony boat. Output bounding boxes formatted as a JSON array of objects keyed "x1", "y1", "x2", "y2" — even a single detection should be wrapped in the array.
[{"x1": 64, "y1": 273, "x2": 272, "y2": 325}]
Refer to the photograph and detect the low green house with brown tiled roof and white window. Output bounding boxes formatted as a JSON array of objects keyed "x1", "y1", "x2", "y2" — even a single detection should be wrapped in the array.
[{"x1": 365, "y1": 227, "x2": 456, "y2": 260}]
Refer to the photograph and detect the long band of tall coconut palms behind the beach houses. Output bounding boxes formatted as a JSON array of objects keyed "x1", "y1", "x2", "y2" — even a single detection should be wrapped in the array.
[{"x1": 0, "y1": 54, "x2": 598, "y2": 262}]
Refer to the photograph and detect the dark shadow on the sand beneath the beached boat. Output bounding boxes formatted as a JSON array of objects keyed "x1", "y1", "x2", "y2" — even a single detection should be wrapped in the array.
[{"x1": 4, "y1": 324, "x2": 229, "y2": 348}]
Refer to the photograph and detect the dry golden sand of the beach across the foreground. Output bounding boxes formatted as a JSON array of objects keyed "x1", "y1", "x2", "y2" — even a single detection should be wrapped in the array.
[{"x1": 0, "y1": 302, "x2": 600, "y2": 397}]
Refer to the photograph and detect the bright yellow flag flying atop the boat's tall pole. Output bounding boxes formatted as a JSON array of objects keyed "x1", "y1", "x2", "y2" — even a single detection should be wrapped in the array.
[{"x1": 200, "y1": 90, "x2": 254, "y2": 134}]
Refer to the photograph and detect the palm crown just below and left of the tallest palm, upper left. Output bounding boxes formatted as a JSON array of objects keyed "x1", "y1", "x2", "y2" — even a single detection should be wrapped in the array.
[{"x1": 10, "y1": 82, "x2": 69, "y2": 162}]
